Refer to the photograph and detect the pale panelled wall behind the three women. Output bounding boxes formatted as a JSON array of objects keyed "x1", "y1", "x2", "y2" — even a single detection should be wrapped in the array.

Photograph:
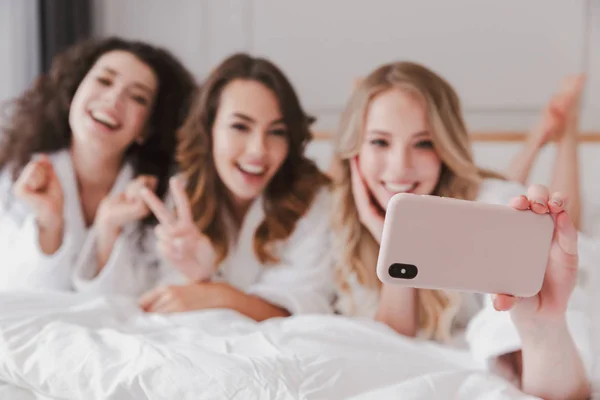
[{"x1": 96, "y1": 0, "x2": 600, "y2": 231}]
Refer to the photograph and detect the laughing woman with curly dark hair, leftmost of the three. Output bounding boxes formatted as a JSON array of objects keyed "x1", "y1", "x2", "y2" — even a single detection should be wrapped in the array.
[{"x1": 0, "y1": 38, "x2": 195, "y2": 294}]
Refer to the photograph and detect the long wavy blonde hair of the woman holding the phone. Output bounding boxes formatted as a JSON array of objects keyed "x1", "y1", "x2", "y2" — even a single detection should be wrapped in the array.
[{"x1": 332, "y1": 62, "x2": 503, "y2": 341}]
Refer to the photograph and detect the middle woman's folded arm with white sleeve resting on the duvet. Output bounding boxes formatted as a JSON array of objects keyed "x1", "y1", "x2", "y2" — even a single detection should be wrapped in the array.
[{"x1": 140, "y1": 189, "x2": 333, "y2": 320}]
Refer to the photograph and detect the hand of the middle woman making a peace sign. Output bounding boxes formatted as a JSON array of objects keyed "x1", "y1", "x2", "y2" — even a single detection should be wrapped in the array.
[{"x1": 141, "y1": 178, "x2": 216, "y2": 281}]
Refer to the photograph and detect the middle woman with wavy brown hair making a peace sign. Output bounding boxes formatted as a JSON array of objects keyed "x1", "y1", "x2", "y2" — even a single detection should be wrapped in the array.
[{"x1": 141, "y1": 54, "x2": 332, "y2": 320}]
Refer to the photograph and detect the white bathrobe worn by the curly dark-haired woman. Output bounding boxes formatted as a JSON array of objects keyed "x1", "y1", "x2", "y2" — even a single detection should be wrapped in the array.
[{"x1": 0, "y1": 150, "x2": 185, "y2": 295}]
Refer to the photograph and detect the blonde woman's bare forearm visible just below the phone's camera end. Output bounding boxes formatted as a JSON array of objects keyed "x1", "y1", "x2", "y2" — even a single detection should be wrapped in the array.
[{"x1": 375, "y1": 284, "x2": 418, "y2": 337}]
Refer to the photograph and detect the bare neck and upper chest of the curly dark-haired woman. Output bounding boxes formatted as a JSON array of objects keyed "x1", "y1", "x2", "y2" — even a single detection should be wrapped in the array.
[{"x1": 71, "y1": 144, "x2": 123, "y2": 191}]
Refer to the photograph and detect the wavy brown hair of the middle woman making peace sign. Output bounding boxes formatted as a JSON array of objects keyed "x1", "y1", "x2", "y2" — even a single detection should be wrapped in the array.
[{"x1": 177, "y1": 53, "x2": 329, "y2": 264}]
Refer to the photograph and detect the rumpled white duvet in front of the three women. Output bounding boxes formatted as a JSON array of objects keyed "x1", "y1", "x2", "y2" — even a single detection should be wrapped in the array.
[{"x1": 0, "y1": 294, "x2": 548, "y2": 400}]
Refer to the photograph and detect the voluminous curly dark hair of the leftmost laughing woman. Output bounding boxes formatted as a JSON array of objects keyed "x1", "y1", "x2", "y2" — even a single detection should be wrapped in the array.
[{"x1": 0, "y1": 37, "x2": 196, "y2": 222}]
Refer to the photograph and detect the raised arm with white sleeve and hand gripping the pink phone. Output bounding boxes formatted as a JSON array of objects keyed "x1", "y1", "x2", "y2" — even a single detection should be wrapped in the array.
[{"x1": 467, "y1": 185, "x2": 591, "y2": 399}]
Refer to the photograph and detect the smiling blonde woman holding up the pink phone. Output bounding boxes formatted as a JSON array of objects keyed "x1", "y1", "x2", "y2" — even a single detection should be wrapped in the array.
[{"x1": 333, "y1": 62, "x2": 589, "y2": 397}]
